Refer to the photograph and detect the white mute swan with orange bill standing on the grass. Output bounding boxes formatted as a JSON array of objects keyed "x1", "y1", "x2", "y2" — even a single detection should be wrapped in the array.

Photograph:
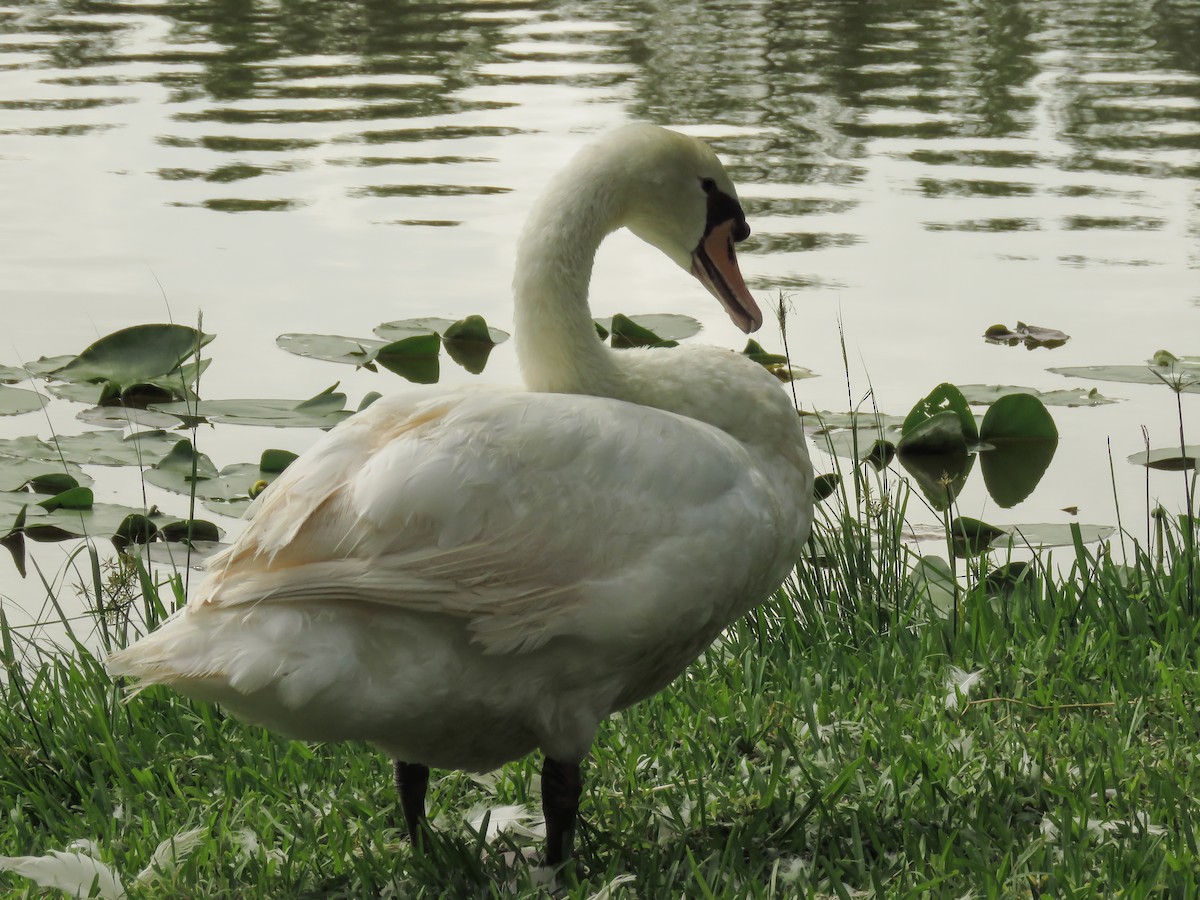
[{"x1": 108, "y1": 125, "x2": 812, "y2": 865}]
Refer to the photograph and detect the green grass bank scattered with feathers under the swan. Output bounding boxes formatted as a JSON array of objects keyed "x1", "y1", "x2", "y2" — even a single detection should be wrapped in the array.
[{"x1": 0, "y1": 494, "x2": 1200, "y2": 899}]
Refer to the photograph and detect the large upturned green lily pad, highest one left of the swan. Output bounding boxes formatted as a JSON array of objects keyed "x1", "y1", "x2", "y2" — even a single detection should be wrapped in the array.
[{"x1": 52, "y1": 325, "x2": 212, "y2": 386}]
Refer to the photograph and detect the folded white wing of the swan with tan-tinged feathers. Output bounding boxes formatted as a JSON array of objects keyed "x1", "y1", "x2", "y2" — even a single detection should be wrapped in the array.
[{"x1": 192, "y1": 391, "x2": 784, "y2": 652}]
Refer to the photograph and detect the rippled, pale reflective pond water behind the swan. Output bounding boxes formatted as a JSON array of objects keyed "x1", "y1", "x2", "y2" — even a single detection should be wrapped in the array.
[{"x1": 0, "y1": 0, "x2": 1200, "y2": 618}]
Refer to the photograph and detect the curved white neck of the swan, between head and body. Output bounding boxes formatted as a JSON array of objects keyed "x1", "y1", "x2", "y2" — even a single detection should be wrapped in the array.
[{"x1": 512, "y1": 152, "x2": 624, "y2": 397}]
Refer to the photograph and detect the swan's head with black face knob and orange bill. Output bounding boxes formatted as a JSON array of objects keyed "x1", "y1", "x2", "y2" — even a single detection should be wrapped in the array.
[{"x1": 605, "y1": 125, "x2": 762, "y2": 334}]
